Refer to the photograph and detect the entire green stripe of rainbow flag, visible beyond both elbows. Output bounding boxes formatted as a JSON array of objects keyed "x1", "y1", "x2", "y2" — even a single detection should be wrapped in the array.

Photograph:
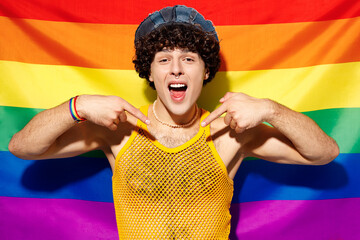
[{"x1": 0, "y1": 106, "x2": 360, "y2": 156}]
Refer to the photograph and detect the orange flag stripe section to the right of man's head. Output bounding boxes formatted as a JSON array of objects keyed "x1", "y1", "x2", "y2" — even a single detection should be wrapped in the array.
[{"x1": 218, "y1": 17, "x2": 360, "y2": 70}]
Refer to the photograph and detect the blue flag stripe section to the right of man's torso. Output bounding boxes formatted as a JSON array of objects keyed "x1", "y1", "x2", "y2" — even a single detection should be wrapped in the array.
[{"x1": 232, "y1": 153, "x2": 360, "y2": 203}]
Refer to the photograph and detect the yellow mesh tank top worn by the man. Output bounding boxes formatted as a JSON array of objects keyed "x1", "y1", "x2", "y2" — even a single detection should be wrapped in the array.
[{"x1": 113, "y1": 106, "x2": 233, "y2": 240}]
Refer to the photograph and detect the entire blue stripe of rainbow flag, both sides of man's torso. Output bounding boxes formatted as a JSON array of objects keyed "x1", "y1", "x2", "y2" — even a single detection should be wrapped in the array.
[{"x1": 0, "y1": 151, "x2": 360, "y2": 203}]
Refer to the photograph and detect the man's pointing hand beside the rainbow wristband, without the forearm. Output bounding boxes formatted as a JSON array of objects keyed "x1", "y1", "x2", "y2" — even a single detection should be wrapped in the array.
[{"x1": 76, "y1": 95, "x2": 150, "y2": 131}]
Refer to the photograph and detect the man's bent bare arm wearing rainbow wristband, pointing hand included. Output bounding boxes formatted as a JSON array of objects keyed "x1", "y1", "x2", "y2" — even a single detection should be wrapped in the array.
[{"x1": 9, "y1": 95, "x2": 148, "y2": 159}]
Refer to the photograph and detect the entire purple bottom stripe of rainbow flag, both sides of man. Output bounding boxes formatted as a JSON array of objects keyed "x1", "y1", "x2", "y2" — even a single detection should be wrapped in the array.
[{"x1": 0, "y1": 197, "x2": 360, "y2": 240}]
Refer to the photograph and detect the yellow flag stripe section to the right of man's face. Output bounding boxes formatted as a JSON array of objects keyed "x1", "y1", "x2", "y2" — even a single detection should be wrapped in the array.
[{"x1": 199, "y1": 62, "x2": 360, "y2": 112}]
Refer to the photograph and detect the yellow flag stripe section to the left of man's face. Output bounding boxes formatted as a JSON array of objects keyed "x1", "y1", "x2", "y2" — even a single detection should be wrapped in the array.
[{"x1": 0, "y1": 61, "x2": 150, "y2": 108}]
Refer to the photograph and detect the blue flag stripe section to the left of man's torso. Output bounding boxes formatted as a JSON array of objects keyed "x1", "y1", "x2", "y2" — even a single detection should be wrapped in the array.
[{"x1": 0, "y1": 151, "x2": 113, "y2": 202}]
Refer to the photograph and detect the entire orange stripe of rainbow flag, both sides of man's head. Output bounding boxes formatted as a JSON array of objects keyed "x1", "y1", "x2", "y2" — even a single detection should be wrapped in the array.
[{"x1": 0, "y1": 17, "x2": 360, "y2": 71}]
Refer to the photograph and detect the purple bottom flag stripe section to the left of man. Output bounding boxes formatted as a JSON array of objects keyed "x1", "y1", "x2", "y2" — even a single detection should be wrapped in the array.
[{"x1": 0, "y1": 197, "x2": 119, "y2": 240}]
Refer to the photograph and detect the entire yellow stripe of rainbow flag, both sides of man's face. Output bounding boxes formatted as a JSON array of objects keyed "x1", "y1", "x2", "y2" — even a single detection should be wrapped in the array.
[{"x1": 0, "y1": 61, "x2": 360, "y2": 111}]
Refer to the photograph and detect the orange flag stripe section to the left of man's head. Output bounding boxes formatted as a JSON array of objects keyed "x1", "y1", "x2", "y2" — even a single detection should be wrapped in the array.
[{"x1": 0, "y1": 17, "x2": 136, "y2": 69}]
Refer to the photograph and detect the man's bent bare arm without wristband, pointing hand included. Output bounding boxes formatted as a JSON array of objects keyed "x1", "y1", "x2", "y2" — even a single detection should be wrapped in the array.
[{"x1": 203, "y1": 93, "x2": 339, "y2": 164}]
